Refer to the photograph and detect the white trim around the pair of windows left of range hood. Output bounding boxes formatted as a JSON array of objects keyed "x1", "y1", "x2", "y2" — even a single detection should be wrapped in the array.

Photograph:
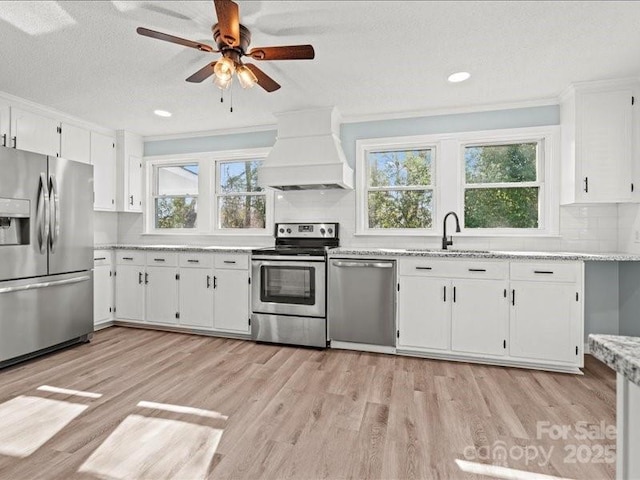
[{"x1": 142, "y1": 148, "x2": 274, "y2": 237}]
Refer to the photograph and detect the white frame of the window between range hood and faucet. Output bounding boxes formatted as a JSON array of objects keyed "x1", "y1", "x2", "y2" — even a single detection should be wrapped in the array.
[{"x1": 356, "y1": 135, "x2": 439, "y2": 236}]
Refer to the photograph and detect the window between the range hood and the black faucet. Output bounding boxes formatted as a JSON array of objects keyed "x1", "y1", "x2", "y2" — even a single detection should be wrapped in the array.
[{"x1": 365, "y1": 148, "x2": 434, "y2": 229}]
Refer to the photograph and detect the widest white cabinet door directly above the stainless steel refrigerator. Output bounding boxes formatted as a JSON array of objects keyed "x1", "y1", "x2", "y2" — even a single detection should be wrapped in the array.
[{"x1": 7, "y1": 107, "x2": 60, "y2": 157}]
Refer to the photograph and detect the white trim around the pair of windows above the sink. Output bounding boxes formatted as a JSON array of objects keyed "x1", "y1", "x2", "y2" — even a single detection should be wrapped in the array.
[{"x1": 355, "y1": 125, "x2": 560, "y2": 237}]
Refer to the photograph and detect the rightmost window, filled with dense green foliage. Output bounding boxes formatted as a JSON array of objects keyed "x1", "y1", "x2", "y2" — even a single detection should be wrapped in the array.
[{"x1": 463, "y1": 142, "x2": 544, "y2": 229}]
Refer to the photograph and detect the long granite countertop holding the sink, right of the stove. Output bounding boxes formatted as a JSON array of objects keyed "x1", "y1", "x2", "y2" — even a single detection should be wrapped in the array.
[{"x1": 329, "y1": 247, "x2": 640, "y2": 262}]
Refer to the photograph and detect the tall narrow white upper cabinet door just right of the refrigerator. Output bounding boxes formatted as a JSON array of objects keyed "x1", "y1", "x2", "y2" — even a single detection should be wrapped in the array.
[{"x1": 91, "y1": 132, "x2": 116, "y2": 211}]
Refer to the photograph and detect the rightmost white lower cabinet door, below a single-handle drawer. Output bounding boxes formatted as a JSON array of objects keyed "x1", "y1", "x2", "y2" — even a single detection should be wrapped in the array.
[{"x1": 509, "y1": 281, "x2": 582, "y2": 363}]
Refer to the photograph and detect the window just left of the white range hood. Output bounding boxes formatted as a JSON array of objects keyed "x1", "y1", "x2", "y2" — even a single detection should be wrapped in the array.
[{"x1": 216, "y1": 160, "x2": 267, "y2": 229}]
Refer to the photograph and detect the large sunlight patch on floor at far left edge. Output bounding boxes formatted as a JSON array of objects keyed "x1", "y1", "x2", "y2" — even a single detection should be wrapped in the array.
[{"x1": 0, "y1": 395, "x2": 88, "y2": 457}]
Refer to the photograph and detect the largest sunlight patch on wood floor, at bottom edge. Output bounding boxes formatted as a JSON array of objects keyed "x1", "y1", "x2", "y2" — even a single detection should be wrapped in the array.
[{"x1": 78, "y1": 415, "x2": 222, "y2": 480}]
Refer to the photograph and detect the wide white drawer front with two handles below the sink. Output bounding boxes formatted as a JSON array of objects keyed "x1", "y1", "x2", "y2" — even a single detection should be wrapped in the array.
[{"x1": 399, "y1": 258, "x2": 509, "y2": 280}]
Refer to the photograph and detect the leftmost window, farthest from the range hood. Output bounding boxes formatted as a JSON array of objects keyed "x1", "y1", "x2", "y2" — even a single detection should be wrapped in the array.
[{"x1": 153, "y1": 163, "x2": 199, "y2": 229}]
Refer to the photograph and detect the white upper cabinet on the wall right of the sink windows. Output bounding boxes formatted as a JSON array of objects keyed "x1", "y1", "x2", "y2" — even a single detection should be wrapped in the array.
[{"x1": 560, "y1": 81, "x2": 640, "y2": 204}]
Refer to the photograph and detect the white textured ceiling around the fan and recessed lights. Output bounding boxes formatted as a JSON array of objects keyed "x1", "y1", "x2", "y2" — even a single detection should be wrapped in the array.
[{"x1": 0, "y1": 0, "x2": 640, "y2": 135}]
